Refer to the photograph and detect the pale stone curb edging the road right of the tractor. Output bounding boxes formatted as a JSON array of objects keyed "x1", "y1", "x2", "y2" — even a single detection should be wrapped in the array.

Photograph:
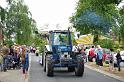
[{"x1": 85, "y1": 64, "x2": 124, "y2": 82}]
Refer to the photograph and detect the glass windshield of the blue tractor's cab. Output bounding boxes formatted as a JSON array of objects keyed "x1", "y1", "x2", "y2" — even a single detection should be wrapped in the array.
[{"x1": 54, "y1": 33, "x2": 69, "y2": 45}]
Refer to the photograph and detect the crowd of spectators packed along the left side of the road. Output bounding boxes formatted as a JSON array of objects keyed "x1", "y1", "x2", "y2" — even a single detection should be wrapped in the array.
[{"x1": 0, "y1": 44, "x2": 36, "y2": 74}]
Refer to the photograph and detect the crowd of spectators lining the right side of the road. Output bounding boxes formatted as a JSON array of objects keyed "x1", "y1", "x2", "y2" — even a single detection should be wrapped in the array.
[{"x1": 76, "y1": 45, "x2": 122, "y2": 71}]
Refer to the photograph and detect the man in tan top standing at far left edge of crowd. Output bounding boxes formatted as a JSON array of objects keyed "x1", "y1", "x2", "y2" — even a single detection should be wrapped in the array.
[{"x1": 2, "y1": 44, "x2": 9, "y2": 72}]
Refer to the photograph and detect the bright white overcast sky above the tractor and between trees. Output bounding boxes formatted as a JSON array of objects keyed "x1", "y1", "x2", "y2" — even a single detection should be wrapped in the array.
[{"x1": 0, "y1": 0, "x2": 124, "y2": 30}]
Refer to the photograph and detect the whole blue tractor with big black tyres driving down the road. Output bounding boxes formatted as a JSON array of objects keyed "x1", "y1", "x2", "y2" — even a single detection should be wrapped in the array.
[{"x1": 43, "y1": 30, "x2": 84, "y2": 76}]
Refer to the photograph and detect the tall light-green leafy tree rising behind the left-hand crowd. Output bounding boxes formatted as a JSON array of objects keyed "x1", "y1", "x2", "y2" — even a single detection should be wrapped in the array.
[{"x1": 6, "y1": 0, "x2": 36, "y2": 45}]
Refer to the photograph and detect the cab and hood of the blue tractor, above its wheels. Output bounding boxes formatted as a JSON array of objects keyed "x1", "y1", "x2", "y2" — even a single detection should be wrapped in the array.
[{"x1": 51, "y1": 31, "x2": 72, "y2": 60}]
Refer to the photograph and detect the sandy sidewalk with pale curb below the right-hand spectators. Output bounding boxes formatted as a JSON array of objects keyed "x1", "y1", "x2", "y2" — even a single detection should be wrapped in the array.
[{"x1": 85, "y1": 62, "x2": 124, "y2": 82}]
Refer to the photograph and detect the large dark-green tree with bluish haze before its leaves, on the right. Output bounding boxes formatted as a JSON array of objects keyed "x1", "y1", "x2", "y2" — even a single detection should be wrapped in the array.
[{"x1": 70, "y1": 0, "x2": 118, "y2": 40}]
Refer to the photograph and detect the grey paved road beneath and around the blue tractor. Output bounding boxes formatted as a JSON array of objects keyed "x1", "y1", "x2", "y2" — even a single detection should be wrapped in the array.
[{"x1": 29, "y1": 55, "x2": 121, "y2": 82}]
